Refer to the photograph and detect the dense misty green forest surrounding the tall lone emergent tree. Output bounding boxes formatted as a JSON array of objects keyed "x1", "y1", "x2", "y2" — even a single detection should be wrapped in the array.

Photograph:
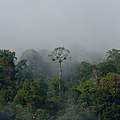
[{"x1": 0, "y1": 49, "x2": 120, "y2": 120}]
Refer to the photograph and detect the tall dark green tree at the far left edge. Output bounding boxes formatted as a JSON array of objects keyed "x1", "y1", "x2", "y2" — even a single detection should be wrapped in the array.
[{"x1": 0, "y1": 50, "x2": 16, "y2": 103}]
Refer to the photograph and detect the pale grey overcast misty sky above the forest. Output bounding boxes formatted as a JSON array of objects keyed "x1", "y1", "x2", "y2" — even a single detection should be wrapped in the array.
[{"x1": 0, "y1": 0, "x2": 120, "y2": 53}]
